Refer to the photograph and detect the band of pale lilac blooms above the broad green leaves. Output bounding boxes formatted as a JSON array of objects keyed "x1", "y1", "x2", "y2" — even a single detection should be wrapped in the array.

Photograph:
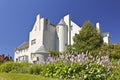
[{"x1": 45, "y1": 53, "x2": 112, "y2": 67}]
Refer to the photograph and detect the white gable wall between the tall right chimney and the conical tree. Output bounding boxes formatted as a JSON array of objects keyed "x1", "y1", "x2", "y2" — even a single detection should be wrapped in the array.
[{"x1": 71, "y1": 21, "x2": 81, "y2": 45}]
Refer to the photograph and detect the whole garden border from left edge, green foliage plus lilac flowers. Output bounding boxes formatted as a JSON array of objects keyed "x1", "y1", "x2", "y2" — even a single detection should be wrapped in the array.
[{"x1": 0, "y1": 53, "x2": 115, "y2": 80}]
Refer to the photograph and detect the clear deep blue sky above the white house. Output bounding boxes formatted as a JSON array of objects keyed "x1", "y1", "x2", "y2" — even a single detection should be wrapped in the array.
[{"x1": 0, "y1": 0, "x2": 120, "y2": 56}]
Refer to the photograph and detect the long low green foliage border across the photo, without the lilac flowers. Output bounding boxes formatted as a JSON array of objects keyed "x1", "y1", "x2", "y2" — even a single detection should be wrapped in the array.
[{"x1": 0, "y1": 58, "x2": 112, "y2": 80}]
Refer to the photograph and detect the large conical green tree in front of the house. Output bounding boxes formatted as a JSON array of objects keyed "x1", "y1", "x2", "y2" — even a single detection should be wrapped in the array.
[{"x1": 73, "y1": 21, "x2": 103, "y2": 53}]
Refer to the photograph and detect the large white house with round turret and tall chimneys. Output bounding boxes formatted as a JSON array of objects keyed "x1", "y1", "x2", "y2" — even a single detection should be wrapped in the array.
[{"x1": 14, "y1": 15, "x2": 111, "y2": 63}]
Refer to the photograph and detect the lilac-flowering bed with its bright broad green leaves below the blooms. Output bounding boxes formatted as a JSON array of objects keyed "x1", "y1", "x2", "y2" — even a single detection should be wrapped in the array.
[{"x1": 42, "y1": 53, "x2": 112, "y2": 80}]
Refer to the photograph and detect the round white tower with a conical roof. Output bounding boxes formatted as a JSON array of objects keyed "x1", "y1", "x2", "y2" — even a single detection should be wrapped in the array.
[{"x1": 57, "y1": 19, "x2": 68, "y2": 52}]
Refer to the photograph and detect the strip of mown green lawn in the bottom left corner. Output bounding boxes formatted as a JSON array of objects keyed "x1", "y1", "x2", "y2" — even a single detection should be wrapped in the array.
[{"x1": 0, "y1": 73, "x2": 59, "y2": 80}]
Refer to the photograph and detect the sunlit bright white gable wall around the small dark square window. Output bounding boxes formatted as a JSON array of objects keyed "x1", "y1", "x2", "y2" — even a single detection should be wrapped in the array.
[{"x1": 29, "y1": 18, "x2": 45, "y2": 62}]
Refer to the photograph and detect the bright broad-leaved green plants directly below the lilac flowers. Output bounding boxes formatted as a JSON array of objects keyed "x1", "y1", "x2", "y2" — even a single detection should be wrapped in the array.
[{"x1": 42, "y1": 62, "x2": 109, "y2": 80}]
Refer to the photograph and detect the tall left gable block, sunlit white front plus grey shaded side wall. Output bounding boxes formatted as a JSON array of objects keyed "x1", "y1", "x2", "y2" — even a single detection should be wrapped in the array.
[{"x1": 29, "y1": 17, "x2": 55, "y2": 63}]
